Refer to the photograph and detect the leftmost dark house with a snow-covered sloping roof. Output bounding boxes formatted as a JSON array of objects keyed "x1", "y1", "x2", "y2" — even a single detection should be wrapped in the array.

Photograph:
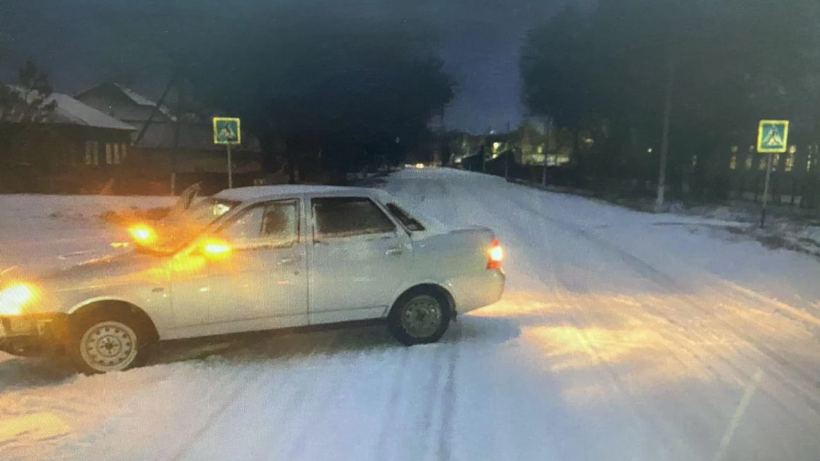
[{"x1": 0, "y1": 93, "x2": 134, "y2": 192}]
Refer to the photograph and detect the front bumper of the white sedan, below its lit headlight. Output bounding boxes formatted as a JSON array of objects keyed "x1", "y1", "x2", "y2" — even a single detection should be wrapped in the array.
[{"x1": 0, "y1": 314, "x2": 68, "y2": 356}]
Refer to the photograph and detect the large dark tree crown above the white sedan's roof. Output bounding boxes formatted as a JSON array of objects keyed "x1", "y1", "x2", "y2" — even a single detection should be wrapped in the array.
[{"x1": 97, "y1": 0, "x2": 453, "y2": 181}]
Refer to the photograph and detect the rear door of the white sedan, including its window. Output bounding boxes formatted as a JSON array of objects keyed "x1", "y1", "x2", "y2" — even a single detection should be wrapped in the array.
[{"x1": 308, "y1": 197, "x2": 412, "y2": 324}]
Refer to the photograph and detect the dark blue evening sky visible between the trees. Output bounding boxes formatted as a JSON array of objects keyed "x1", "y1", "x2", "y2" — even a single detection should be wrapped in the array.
[{"x1": 0, "y1": 0, "x2": 563, "y2": 133}]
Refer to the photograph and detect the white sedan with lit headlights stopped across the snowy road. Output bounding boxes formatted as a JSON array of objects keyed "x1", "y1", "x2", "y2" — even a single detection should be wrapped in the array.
[{"x1": 0, "y1": 186, "x2": 505, "y2": 373}]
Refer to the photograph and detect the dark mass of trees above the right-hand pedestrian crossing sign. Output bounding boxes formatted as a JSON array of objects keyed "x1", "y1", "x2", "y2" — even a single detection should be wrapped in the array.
[{"x1": 520, "y1": 0, "x2": 820, "y2": 196}]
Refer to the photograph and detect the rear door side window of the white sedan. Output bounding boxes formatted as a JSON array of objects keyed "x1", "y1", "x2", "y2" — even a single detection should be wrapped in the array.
[{"x1": 311, "y1": 197, "x2": 396, "y2": 239}]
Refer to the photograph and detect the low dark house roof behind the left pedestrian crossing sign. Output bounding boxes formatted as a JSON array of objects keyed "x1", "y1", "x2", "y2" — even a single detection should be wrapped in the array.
[{"x1": 137, "y1": 122, "x2": 261, "y2": 152}]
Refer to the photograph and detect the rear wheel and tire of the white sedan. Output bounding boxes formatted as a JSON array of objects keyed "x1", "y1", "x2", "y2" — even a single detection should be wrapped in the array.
[{"x1": 387, "y1": 288, "x2": 451, "y2": 346}]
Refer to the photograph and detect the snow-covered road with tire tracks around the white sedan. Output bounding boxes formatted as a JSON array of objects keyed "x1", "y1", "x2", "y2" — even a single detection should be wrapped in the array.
[{"x1": 0, "y1": 170, "x2": 820, "y2": 461}]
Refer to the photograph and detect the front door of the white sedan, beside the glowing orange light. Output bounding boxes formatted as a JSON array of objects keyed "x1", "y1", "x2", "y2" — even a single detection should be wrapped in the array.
[{"x1": 208, "y1": 198, "x2": 307, "y2": 332}]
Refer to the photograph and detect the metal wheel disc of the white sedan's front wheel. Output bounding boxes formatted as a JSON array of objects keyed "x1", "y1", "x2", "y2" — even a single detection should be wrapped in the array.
[{"x1": 80, "y1": 321, "x2": 137, "y2": 372}]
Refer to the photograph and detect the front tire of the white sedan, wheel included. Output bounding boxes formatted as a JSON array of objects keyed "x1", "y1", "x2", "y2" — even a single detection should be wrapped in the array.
[{"x1": 67, "y1": 310, "x2": 146, "y2": 375}]
